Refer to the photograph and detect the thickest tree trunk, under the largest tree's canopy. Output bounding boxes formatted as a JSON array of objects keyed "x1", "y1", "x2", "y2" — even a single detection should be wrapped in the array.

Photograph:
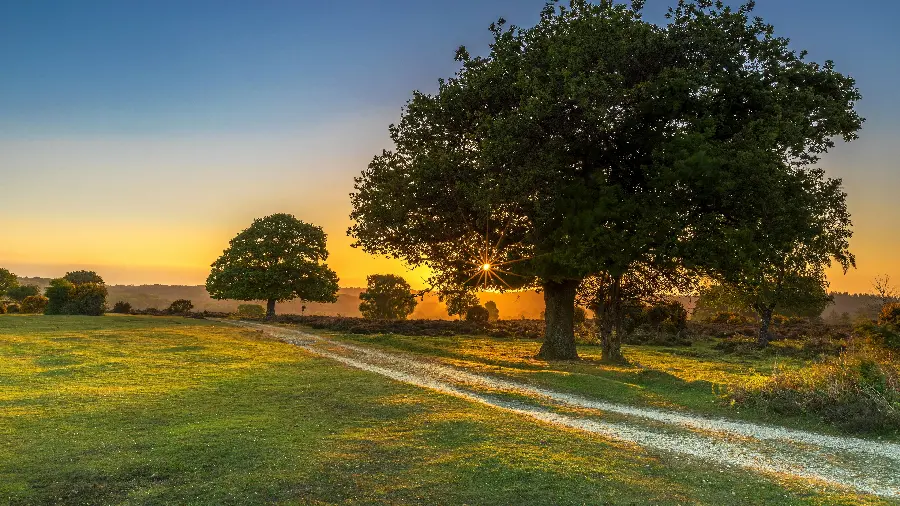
[{"x1": 537, "y1": 279, "x2": 580, "y2": 360}]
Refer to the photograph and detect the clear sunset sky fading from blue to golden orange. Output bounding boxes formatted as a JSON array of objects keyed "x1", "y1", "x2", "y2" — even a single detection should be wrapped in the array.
[{"x1": 0, "y1": 0, "x2": 900, "y2": 292}]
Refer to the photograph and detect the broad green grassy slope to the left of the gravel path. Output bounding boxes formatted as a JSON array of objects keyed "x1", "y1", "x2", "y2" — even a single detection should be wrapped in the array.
[{"x1": 0, "y1": 316, "x2": 884, "y2": 504}]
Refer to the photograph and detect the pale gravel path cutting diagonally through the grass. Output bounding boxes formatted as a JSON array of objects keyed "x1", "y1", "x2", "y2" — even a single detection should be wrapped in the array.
[{"x1": 227, "y1": 321, "x2": 900, "y2": 498}]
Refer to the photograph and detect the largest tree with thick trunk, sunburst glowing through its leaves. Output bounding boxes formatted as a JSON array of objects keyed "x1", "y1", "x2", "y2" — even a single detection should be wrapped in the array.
[{"x1": 349, "y1": 0, "x2": 861, "y2": 358}]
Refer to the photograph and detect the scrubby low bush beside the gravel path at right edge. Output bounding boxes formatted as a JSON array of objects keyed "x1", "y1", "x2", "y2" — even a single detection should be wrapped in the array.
[{"x1": 727, "y1": 341, "x2": 900, "y2": 432}]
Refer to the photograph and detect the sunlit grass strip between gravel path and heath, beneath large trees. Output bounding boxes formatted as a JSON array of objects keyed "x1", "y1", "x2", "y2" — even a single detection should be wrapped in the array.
[{"x1": 319, "y1": 331, "x2": 900, "y2": 441}]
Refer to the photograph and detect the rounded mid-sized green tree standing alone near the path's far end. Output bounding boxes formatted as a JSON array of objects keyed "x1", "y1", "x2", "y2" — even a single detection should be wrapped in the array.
[{"x1": 206, "y1": 214, "x2": 339, "y2": 317}]
